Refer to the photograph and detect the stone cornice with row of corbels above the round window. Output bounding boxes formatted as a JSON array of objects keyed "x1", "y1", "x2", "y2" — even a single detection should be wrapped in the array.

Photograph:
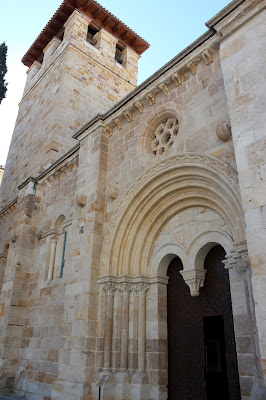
[{"x1": 104, "y1": 44, "x2": 215, "y2": 137}]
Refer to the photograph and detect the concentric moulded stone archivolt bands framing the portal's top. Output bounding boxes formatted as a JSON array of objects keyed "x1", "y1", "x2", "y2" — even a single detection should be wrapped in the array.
[{"x1": 101, "y1": 153, "x2": 245, "y2": 275}]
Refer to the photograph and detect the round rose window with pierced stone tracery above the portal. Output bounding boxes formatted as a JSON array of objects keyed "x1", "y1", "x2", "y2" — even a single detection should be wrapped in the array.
[{"x1": 151, "y1": 118, "x2": 178, "y2": 156}]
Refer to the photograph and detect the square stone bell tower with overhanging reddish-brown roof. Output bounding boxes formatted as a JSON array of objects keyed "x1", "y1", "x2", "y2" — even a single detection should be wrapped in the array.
[{"x1": 1, "y1": 0, "x2": 149, "y2": 208}]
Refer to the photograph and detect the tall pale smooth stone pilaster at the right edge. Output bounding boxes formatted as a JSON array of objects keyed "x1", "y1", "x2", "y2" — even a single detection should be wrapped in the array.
[{"x1": 218, "y1": 1, "x2": 266, "y2": 388}]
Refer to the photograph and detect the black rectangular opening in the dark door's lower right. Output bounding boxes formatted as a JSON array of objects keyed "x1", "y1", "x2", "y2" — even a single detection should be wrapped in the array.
[{"x1": 203, "y1": 315, "x2": 229, "y2": 400}]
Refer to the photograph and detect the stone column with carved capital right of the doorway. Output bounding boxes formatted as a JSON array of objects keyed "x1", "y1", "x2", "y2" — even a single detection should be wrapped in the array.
[{"x1": 223, "y1": 243, "x2": 263, "y2": 398}]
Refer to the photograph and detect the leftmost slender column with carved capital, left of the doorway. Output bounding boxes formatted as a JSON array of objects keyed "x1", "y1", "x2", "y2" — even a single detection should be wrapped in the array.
[{"x1": 103, "y1": 282, "x2": 116, "y2": 371}]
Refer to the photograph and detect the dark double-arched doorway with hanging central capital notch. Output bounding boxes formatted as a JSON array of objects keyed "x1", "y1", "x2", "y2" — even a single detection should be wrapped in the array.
[{"x1": 167, "y1": 246, "x2": 241, "y2": 400}]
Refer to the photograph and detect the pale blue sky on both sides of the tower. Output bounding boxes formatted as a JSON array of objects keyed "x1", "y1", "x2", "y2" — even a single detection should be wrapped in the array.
[{"x1": 0, "y1": 0, "x2": 229, "y2": 165}]
